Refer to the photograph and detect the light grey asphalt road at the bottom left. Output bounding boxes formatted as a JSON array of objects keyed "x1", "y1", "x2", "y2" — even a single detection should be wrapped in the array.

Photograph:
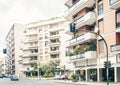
[{"x1": 0, "y1": 78, "x2": 72, "y2": 85}]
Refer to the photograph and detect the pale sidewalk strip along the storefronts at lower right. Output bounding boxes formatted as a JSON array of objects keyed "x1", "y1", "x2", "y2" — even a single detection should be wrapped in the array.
[{"x1": 55, "y1": 80, "x2": 120, "y2": 85}]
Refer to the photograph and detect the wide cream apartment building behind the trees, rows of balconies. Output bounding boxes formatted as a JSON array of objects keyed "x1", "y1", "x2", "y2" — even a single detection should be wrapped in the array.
[{"x1": 20, "y1": 17, "x2": 68, "y2": 77}]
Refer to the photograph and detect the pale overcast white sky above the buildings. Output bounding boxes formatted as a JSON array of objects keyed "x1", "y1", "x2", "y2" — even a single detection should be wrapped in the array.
[{"x1": 0, "y1": 0, "x2": 66, "y2": 48}]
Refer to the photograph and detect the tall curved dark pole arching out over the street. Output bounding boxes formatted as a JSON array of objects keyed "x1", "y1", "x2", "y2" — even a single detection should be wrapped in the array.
[{"x1": 77, "y1": 29, "x2": 109, "y2": 85}]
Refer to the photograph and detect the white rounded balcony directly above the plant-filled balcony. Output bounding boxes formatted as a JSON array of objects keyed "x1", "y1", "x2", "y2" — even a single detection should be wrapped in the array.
[{"x1": 66, "y1": 33, "x2": 96, "y2": 47}]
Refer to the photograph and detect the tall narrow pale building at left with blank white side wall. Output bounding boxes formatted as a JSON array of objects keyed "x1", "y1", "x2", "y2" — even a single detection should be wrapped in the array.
[{"x1": 6, "y1": 23, "x2": 24, "y2": 76}]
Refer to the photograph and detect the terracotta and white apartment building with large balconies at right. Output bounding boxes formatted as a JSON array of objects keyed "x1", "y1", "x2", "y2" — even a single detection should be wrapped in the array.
[{"x1": 65, "y1": 0, "x2": 120, "y2": 82}]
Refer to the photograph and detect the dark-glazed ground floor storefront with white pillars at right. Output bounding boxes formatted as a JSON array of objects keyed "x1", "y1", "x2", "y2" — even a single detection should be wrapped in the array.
[{"x1": 75, "y1": 67, "x2": 120, "y2": 82}]
